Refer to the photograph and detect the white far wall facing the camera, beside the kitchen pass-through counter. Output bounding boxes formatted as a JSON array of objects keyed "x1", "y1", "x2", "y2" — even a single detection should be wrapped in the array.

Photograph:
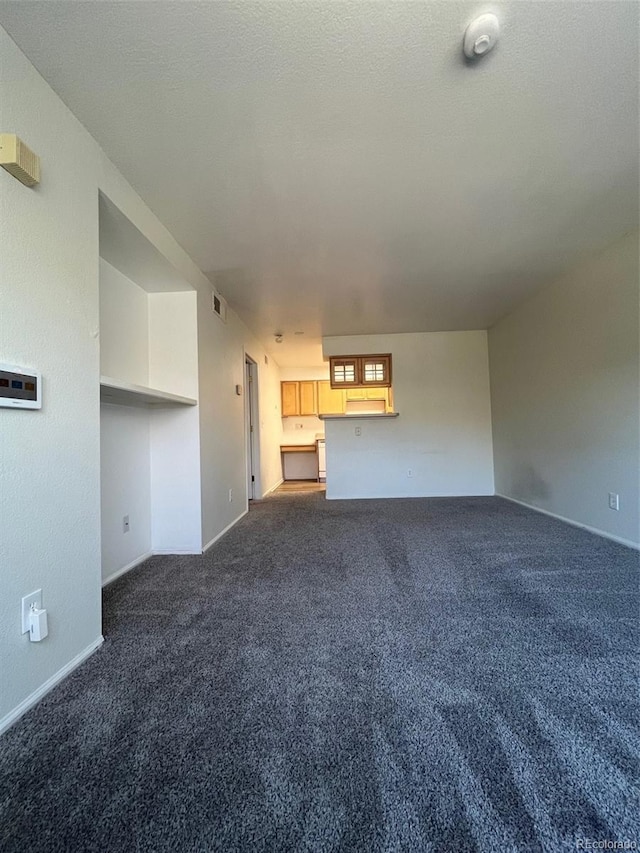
[{"x1": 323, "y1": 331, "x2": 493, "y2": 498}]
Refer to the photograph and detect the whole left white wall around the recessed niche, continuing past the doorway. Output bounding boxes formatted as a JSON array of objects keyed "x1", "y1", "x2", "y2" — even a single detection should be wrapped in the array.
[{"x1": 0, "y1": 28, "x2": 281, "y2": 730}]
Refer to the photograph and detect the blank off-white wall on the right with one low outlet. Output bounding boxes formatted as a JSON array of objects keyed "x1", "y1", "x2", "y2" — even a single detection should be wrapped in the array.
[{"x1": 489, "y1": 232, "x2": 640, "y2": 543}]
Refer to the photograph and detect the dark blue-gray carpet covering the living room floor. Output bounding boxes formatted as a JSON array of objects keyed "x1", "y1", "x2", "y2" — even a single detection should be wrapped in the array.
[{"x1": 0, "y1": 494, "x2": 640, "y2": 853}]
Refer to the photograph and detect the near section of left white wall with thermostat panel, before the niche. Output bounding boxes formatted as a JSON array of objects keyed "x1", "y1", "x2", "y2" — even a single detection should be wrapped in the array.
[{"x1": 0, "y1": 25, "x2": 101, "y2": 727}]
